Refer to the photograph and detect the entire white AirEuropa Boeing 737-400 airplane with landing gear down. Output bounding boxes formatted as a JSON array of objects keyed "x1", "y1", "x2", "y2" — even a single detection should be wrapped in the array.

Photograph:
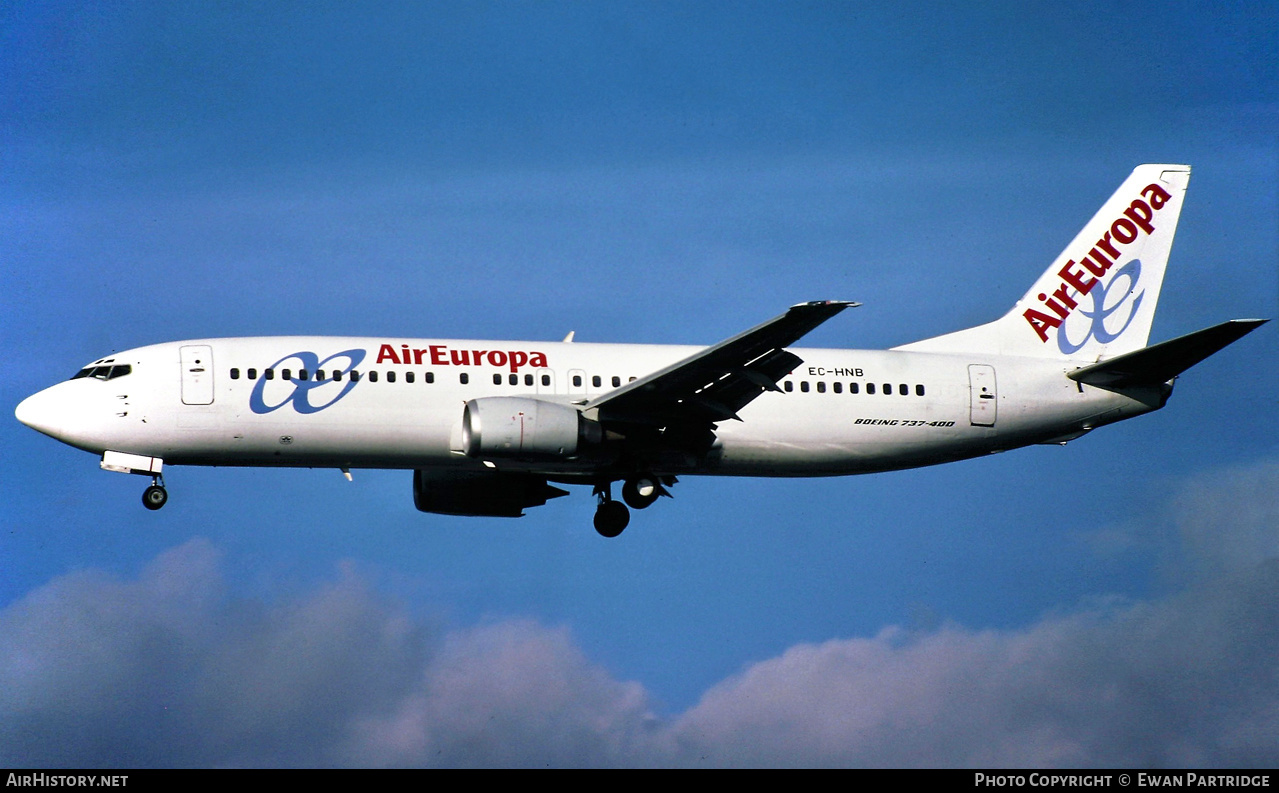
[{"x1": 15, "y1": 164, "x2": 1267, "y2": 537}]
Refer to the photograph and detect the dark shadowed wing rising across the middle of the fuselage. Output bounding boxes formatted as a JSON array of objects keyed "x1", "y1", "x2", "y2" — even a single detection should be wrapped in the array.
[{"x1": 583, "y1": 301, "x2": 861, "y2": 426}]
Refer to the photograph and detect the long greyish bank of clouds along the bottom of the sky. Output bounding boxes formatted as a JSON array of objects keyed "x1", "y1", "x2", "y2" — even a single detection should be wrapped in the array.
[{"x1": 0, "y1": 464, "x2": 1279, "y2": 767}]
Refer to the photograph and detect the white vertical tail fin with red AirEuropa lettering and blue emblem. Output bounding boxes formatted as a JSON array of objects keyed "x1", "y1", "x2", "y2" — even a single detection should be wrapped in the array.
[{"x1": 895, "y1": 165, "x2": 1191, "y2": 361}]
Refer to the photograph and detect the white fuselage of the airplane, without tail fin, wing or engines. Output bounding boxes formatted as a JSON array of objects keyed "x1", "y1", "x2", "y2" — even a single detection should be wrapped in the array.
[{"x1": 18, "y1": 336, "x2": 1168, "y2": 481}]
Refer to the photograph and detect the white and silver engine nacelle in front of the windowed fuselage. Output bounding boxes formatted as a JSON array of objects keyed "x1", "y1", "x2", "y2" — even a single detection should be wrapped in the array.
[{"x1": 462, "y1": 397, "x2": 604, "y2": 457}]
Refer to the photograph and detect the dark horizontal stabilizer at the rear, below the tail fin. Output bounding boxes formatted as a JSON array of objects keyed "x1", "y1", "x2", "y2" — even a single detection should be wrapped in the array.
[{"x1": 1067, "y1": 320, "x2": 1269, "y2": 388}]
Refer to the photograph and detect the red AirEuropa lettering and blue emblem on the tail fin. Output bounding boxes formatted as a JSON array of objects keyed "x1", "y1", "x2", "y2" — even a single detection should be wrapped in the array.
[{"x1": 1022, "y1": 184, "x2": 1172, "y2": 354}]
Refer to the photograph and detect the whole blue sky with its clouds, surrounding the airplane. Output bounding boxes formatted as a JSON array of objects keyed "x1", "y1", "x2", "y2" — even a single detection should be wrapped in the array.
[{"x1": 0, "y1": 3, "x2": 1279, "y2": 766}]
